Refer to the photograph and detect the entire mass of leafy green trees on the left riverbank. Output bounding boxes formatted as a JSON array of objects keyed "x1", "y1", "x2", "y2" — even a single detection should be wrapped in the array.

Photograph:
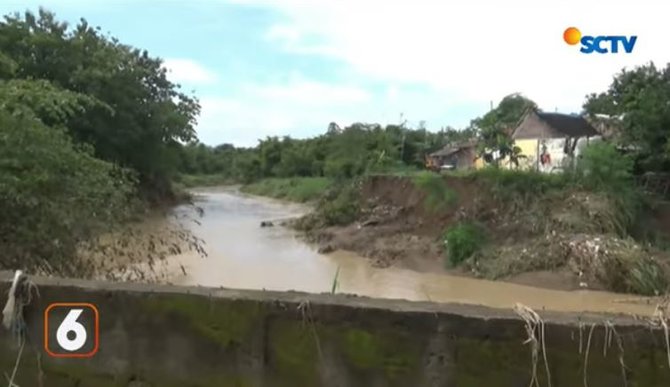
[{"x1": 0, "y1": 10, "x2": 209, "y2": 276}]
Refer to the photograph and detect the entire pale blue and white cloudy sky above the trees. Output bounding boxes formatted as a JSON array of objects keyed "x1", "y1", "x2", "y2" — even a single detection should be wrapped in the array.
[{"x1": 0, "y1": 0, "x2": 670, "y2": 146}]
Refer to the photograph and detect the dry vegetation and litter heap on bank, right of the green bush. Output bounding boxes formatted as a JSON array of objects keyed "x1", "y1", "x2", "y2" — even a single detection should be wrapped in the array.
[{"x1": 465, "y1": 186, "x2": 670, "y2": 295}]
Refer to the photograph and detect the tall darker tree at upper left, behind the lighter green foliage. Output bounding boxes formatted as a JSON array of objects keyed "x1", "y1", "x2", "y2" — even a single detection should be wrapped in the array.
[{"x1": 0, "y1": 9, "x2": 200, "y2": 198}]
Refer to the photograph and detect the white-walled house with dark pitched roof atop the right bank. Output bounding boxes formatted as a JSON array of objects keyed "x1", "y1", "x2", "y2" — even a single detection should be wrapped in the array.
[{"x1": 512, "y1": 110, "x2": 601, "y2": 172}]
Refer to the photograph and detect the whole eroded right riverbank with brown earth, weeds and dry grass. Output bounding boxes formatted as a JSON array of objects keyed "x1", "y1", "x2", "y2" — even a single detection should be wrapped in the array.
[{"x1": 298, "y1": 171, "x2": 670, "y2": 295}]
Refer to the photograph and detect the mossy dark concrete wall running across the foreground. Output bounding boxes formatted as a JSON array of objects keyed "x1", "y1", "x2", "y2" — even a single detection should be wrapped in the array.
[{"x1": 0, "y1": 273, "x2": 670, "y2": 387}]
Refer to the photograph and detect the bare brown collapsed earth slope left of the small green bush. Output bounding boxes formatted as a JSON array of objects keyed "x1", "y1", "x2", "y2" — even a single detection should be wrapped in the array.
[{"x1": 298, "y1": 176, "x2": 477, "y2": 271}]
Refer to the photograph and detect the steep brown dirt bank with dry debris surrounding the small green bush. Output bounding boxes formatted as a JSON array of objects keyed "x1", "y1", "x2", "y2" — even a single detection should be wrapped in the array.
[{"x1": 298, "y1": 176, "x2": 670, "y2": 294}]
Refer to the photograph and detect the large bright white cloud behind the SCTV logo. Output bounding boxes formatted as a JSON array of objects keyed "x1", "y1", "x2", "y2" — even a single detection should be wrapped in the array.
[{"x1": 253, "y1": 0, "x2": 670, "y2": 111}]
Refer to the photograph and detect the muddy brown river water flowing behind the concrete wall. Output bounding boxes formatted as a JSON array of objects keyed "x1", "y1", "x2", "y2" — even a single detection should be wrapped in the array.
[{"x1": 165, "y1": 189, "x2": 653, "y2": 315}]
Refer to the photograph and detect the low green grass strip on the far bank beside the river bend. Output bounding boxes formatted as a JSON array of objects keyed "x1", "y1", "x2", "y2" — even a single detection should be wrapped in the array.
[{"x1": 242, "y1": 177, "x2": 332, "y2": 203}]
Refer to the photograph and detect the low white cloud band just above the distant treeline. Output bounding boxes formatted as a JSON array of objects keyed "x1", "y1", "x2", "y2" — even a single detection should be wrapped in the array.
[{"x1": 198, "y1": 76, "x2": 472, "y2": 146}]
